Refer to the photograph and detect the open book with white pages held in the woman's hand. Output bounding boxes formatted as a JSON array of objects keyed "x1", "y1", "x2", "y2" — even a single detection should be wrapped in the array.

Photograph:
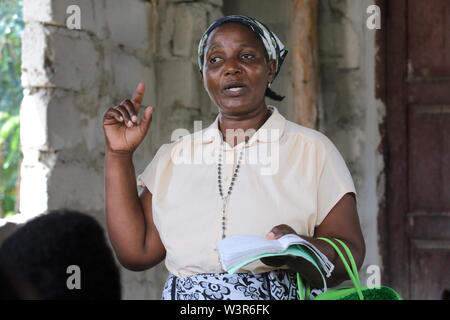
[{"x1": 217, "y1": 234, "x2": 334, "y2": 289}]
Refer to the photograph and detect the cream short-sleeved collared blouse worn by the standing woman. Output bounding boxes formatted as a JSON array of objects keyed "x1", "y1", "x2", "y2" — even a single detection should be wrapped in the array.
[{"x1": 137, "y1": 106, "x2": 356, "y2": 277}]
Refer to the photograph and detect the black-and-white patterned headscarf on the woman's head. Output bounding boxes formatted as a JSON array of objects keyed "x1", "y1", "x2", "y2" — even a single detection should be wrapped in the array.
[{"x1": 198, "y1": 15, "x2": 288, "y2": 79}]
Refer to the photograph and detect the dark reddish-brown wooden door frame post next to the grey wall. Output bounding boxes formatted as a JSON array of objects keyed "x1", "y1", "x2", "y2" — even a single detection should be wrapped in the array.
[{"x1": 376, "y1": 0, "x2": 410, "y2": 299}]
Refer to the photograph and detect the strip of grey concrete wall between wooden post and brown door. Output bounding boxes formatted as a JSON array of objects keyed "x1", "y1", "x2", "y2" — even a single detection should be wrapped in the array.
[{"x1": 319, "y1": 0, "x2": 385, "y2": 283}]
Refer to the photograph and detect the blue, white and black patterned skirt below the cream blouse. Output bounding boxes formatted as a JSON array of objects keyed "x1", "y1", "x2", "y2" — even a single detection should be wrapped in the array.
[{"x1": 162, "y1": 270, "x2": 322, "y2": 300}]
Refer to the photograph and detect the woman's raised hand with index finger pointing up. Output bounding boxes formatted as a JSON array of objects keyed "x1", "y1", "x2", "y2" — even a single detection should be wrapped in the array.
[{"x1": 103, "y1": 82, "x2": 153, "y2": 153}]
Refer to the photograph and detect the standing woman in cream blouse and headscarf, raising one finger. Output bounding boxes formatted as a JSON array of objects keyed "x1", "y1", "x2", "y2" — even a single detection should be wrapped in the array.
[{"x1": 103, "y1": 16, "x2": 365, "y2": 299}]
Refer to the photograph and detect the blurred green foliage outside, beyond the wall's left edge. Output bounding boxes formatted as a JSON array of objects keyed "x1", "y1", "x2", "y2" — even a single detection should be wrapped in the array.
[{"x1": 0, "y1": 0, "x2": 24, "y2": 217}]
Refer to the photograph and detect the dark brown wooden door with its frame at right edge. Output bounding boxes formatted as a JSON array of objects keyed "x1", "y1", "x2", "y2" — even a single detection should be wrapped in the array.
[{"x1": 382, "y1": 0, "x2": 450, "y2": 299}]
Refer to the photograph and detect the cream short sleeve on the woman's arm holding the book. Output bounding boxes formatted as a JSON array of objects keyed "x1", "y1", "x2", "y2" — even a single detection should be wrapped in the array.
[{"x1": 316, "y1": 133, "x2": 356, "y2": 226}]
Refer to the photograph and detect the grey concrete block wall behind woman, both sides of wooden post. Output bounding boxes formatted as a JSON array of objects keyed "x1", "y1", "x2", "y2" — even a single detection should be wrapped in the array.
[{"x1": 0, "y1": 0, "x2": 384, "y2": 299}]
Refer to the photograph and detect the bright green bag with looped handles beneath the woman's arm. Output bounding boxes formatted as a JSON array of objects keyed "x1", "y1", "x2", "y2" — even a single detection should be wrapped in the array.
[{"x1": 297, "y1": 238, "x2": 403, "y2": 300}]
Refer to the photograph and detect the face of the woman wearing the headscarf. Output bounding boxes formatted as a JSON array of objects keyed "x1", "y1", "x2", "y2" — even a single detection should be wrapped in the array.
[{"x1": 202, "y1": 23, "x2": 276, "y2": 114}]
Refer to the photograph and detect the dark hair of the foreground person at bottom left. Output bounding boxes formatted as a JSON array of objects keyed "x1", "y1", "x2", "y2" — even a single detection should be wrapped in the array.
[{"x1": 0, "y1": 209, "x2": 121, "y2": 299}]
